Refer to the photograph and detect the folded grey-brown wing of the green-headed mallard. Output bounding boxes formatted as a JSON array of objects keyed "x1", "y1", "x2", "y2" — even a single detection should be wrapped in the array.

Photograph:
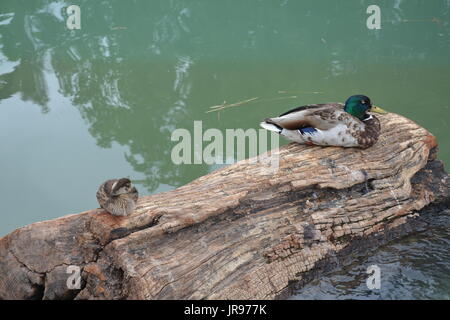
[{"x1": 265, "y1": 103, "x2": 346, "y2": 130}]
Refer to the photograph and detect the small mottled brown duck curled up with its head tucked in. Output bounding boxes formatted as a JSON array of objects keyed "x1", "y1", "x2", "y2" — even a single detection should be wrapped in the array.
[{"x1": 97, "y1": 178, "x2": 139, "y2": 216}]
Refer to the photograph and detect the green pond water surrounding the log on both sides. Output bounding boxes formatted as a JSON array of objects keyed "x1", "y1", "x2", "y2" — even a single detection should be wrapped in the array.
[{"x1": 0, "y1": 0, "x2": 450, "y2": 299}]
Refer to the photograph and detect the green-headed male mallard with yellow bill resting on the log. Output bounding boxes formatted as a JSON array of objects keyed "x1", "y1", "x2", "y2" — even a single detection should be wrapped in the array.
[{"x1": 261, "y1": 95, "x2": 386, "y2": 148}]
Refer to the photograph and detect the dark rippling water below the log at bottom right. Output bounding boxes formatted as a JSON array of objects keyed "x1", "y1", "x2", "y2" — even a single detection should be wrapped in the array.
[{"x1": 292, "y1": 211, "x2": 450, "y2": 300}]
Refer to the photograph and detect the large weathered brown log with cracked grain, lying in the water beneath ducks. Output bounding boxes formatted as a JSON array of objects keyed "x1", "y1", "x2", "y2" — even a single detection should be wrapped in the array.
[{"x1": 0, "y1": 114, "x2": 450, "y2": 299}]
